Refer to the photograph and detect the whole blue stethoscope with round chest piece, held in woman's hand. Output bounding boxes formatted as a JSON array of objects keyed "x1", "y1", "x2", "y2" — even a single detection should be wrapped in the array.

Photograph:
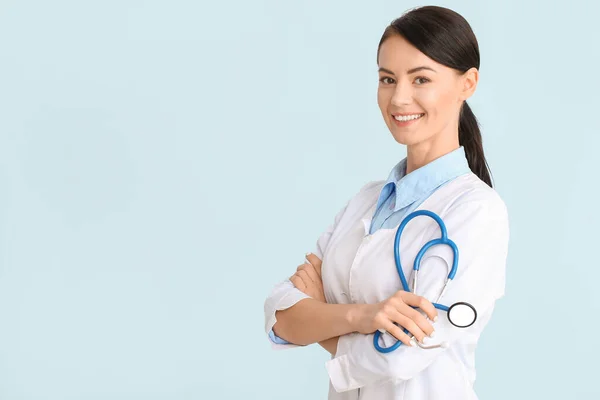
[{"x1": 373, "y1": 210, "x2": 477, "y2": 353}]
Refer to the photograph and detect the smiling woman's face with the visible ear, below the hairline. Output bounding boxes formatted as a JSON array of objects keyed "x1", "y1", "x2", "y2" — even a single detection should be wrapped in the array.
[{"x1": 377, "y1": 35, "x2": 478, "y2": 146}]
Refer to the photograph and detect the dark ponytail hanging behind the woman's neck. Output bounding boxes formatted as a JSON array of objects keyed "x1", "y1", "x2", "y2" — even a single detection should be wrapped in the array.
[{"x1": 458, "y1": 101, "x2": 493, "y2": 187}]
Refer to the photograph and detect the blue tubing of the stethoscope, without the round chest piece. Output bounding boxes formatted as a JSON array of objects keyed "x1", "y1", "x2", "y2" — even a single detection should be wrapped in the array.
[{"x1": 373, "y1": 210, "x2": 458, "y2": 353}]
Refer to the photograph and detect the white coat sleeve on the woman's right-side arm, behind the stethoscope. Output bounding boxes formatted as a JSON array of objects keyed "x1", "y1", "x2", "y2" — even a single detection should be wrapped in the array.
[{"x1": 326, "y1": 197, "x2": 509, "y2": 392}]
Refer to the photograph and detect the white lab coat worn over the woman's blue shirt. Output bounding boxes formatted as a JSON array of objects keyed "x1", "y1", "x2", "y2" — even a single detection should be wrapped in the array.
[{"x1": 265, "y1": 173, "x2": 509, "y2": 400}]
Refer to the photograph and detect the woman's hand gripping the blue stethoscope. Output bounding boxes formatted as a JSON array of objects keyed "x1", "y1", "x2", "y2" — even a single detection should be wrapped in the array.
[{"x1": 351, "y1": 290, "x2": 437, "y2": 346}]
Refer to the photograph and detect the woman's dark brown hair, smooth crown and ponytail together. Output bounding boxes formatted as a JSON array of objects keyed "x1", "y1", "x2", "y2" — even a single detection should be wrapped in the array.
[{"x1": 377, "y1": 6, "x2": 493, "y2": 187}]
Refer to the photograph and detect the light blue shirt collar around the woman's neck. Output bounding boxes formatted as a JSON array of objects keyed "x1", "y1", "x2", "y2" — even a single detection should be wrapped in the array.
[{"x1": 377, "y1": 146, "x2": 470, "y2": 212}]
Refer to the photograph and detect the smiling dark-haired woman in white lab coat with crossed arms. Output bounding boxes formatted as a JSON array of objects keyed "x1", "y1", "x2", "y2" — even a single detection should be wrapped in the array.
[{"x1": 265, "y1": 6, "x2": 509, "y2": 400}]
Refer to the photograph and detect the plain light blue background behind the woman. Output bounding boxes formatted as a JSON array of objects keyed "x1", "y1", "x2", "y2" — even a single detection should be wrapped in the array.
[{"x1": 0, "y1": 0, "x2": 600, "y2": 400}]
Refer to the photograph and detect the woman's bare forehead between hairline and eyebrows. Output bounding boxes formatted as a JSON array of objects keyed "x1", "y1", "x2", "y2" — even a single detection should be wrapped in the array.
[{"x1": 378, "y1": 35, "x2": 441, "y2": 72}]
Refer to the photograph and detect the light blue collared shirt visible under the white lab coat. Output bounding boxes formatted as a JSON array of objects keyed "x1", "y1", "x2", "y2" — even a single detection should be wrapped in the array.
[{"x1": 269, "y1": 146, "x2": 471, "y2": 344}]
